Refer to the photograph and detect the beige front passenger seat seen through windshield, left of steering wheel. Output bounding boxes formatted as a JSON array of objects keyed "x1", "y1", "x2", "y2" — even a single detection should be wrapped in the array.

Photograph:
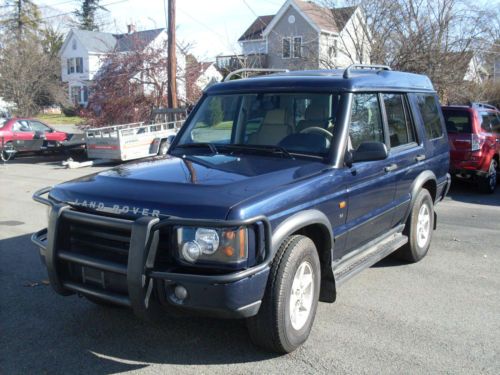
[{"x1": 248, "y1": 109, "x2": 292, "y2": 145}]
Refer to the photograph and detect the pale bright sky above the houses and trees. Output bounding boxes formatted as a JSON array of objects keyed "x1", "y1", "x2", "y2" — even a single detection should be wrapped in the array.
[{"x1": 35, "y1": 0, "x2": 285, "y2": 60}]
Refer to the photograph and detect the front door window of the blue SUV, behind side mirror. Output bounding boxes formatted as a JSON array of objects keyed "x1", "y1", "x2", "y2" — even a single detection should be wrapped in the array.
[{"x1": 349, "y1": 94, "x2": 384, "y2": 150}]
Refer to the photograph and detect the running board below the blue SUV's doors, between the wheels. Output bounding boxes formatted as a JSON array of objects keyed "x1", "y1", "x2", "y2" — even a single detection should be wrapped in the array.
[{"x1": 332, "y1": 225, "x2": 408, "y2": 287}]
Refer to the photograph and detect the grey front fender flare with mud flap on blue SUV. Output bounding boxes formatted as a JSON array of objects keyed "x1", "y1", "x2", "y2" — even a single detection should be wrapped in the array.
[{"x1": 271, "y1": 209, "x2": 336, "y2": 302}]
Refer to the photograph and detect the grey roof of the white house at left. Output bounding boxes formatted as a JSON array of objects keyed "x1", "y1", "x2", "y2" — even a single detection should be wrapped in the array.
[{"x1": 71, "y1": 29, "x2": 164, "y2": 53}]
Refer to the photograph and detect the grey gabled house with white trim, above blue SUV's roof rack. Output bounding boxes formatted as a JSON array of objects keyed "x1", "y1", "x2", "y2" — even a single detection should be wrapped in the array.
[{"x1": 218, "y1": 0, "x2": 371, "y2": 70}]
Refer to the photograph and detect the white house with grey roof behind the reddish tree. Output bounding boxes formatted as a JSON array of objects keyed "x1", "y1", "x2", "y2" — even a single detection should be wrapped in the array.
[{"x1": 59, "y1": 26, "x2": 186, "y2": 106}]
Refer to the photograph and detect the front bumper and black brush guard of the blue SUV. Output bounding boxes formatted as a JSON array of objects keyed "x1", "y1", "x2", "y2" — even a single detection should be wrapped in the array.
[{"x1": 32, "y1": 188, "x2": 272, "y2": 319}]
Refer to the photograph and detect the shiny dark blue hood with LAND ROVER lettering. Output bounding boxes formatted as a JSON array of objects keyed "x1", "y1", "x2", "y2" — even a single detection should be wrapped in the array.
[{"x1": 50, "y1": 154, "x2": 327, "y2": 220}]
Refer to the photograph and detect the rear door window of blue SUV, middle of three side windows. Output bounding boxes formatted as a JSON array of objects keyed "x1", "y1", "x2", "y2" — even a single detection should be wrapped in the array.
[{"x1": 382, "y1": 94, "x2": 415, "y2": 147}]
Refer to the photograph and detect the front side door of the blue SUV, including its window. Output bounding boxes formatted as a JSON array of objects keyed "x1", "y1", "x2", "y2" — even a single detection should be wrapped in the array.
[{"x1": 342, "y1": 93, "x2": 397, "y2": 255}]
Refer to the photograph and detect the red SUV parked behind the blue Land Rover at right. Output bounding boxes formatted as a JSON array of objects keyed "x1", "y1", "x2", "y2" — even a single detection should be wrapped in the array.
[{"x1": 442, "y1": 103, "x2": 500, "y2": 193}]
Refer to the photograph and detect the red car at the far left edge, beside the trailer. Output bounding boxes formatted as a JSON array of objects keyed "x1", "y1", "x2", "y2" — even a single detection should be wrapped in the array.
[{"x1": 0, "y1": 118, "x2": 68, "y2": 159}]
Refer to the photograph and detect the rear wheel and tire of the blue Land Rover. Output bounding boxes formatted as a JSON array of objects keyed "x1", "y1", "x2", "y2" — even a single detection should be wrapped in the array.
[{"x1": 394, "y1": 189, "x2": 434, "y2": 263}]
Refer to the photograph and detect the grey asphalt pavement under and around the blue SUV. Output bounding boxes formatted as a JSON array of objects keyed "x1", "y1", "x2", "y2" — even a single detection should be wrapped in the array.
[{"x1": 0, "y1": 153, "x2": 500, "y2": 374}]
